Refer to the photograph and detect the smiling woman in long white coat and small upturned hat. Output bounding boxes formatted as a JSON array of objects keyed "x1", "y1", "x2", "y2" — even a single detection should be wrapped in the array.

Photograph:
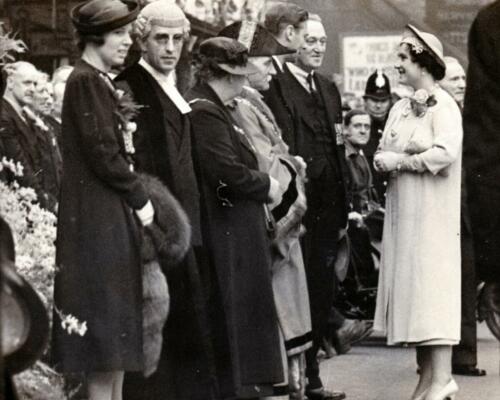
[{"x1": 374, "y1": 25, "x2": 463, "y2": 400}]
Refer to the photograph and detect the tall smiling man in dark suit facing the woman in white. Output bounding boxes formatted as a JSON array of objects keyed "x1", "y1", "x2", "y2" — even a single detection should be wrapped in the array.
[{"x1": 268, "y1": 10, "x2": 347, "y2": 400}]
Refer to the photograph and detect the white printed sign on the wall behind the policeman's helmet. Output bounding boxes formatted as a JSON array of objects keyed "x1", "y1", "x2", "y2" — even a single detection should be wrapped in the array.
[{"x1": 342, "y1": 33, "x2": 401, "y2": 96}]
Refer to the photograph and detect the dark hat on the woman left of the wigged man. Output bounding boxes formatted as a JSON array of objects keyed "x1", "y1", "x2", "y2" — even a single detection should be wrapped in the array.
[{"x1": 70, "y1": 0, "x2": 140, "y2": 35}]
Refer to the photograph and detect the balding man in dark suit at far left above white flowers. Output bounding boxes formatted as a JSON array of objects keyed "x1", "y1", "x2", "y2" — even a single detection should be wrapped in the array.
[{"x1": 0, "y1": 61, "x2": 50, "y2": 207}]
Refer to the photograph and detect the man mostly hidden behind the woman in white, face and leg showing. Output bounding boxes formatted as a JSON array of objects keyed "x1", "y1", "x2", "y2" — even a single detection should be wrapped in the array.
[{"x1": 440, "y1": 57, "x2": 486, "y2": 376}]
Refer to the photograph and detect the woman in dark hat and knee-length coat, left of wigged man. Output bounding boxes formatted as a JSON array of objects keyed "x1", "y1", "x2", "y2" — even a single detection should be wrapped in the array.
[{"x1": 52, "y1": 0, "x2": 154, "y2": 400}]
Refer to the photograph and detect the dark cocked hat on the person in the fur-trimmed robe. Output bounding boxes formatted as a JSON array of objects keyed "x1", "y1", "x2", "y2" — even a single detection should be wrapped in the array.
[{"x1": 219, "y1": 21, "x2": 295, "y2": 57}]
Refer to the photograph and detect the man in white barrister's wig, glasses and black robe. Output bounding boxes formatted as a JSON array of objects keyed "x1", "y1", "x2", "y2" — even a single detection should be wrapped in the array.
[{"x1": 116, "y1": 0, "x2": 216, "y2": 400}]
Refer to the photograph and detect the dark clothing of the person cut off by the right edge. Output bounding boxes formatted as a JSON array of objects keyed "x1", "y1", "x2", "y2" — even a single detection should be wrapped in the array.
[{"x1": 463, "y1": 1, "x2": 500, "y2": 282}]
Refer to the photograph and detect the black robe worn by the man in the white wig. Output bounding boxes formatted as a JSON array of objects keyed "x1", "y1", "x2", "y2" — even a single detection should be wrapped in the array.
[{"x1": 116, "y1": 63, "x2": 214, "y2": 400}]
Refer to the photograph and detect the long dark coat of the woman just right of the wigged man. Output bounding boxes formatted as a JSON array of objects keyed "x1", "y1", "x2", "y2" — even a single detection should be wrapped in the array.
[{"x1": 187, "y1": 85, "x2": 284, "y2": 398}]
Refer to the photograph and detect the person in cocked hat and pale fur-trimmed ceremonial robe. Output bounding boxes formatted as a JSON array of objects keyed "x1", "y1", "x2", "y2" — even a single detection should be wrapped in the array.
[{"x1": 219, "y1": 21, "x2": 312, "y2": 399}]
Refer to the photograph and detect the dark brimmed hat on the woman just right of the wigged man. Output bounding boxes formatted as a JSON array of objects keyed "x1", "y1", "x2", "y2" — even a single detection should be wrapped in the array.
[{"x1": 199, "y1": 36, "x2": 259, "y2": 75}]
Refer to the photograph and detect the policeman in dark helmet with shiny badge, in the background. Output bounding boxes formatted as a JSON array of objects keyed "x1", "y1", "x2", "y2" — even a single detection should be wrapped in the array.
[{"x1": 363, "y1": 70, "x2": 392, "y2": 204}]
